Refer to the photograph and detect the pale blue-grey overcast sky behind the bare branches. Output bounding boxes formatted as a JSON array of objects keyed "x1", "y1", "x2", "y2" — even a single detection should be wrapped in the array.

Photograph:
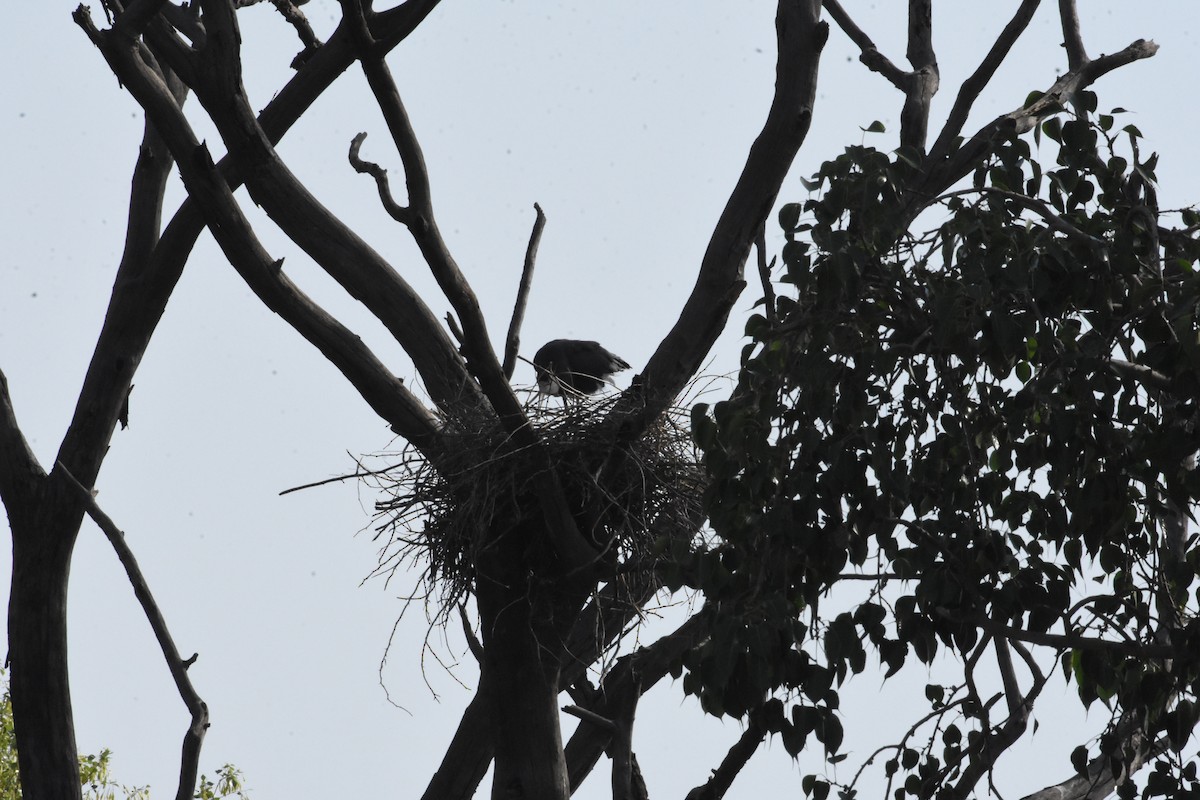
[{"x1": 0, "y1": 0, "x2": 1200, "y2": 800}]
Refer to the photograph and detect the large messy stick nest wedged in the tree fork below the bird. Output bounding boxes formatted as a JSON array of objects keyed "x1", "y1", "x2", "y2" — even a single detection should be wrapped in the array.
[{"x1": 367, "y1": 396, "x2": 704, "y2": 616}]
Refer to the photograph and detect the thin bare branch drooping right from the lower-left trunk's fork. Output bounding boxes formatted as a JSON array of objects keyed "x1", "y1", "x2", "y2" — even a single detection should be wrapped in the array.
[{"x1": 58, "y1": 462, "x2": 209, "y2": 800}]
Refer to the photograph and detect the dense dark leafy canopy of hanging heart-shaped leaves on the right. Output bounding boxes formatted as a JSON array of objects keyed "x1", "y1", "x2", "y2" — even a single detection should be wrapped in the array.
[{"x1": 691, "y1": 100, "x2": 1200, "y2": 800}]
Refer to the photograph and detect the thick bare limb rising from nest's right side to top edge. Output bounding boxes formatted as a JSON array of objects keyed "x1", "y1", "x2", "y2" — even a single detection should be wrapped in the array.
[{"x1": 611, "y1": 0, "x2": 829, "y2": 439}]
